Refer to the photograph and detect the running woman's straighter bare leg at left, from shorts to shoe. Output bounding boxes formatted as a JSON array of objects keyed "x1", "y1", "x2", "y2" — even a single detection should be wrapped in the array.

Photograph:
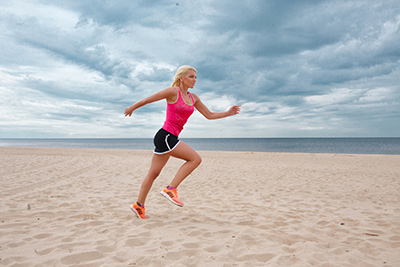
[{"x1": 138, "y1": 153, "x2": 170, "y2": 206}]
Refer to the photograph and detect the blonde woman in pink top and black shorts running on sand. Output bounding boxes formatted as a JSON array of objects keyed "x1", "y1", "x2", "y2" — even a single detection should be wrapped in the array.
[{"x1": 125, "y1": 66, "x2": 240, "y2": 219}]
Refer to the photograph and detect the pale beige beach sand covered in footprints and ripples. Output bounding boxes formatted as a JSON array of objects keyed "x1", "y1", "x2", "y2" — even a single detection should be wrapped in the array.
[{"x1": 0, "y1": 147, "x2": 400, "y2": 266}]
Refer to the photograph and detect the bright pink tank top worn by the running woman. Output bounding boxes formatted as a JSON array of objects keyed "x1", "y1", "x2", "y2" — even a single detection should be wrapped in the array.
[{"x1": 162, "y1": 87, "x2": 194, "y2": 136}]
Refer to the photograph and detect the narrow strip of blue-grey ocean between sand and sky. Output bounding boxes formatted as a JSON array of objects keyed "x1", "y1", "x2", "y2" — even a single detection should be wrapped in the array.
[{"x1": 0, "y1": 138, "x2": 400, "y2": 155}]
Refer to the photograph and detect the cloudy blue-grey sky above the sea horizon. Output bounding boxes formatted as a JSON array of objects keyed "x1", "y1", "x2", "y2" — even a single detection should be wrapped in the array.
[{"x1": 0, "y1": 0, "x2": 400, "y2": 138}]
